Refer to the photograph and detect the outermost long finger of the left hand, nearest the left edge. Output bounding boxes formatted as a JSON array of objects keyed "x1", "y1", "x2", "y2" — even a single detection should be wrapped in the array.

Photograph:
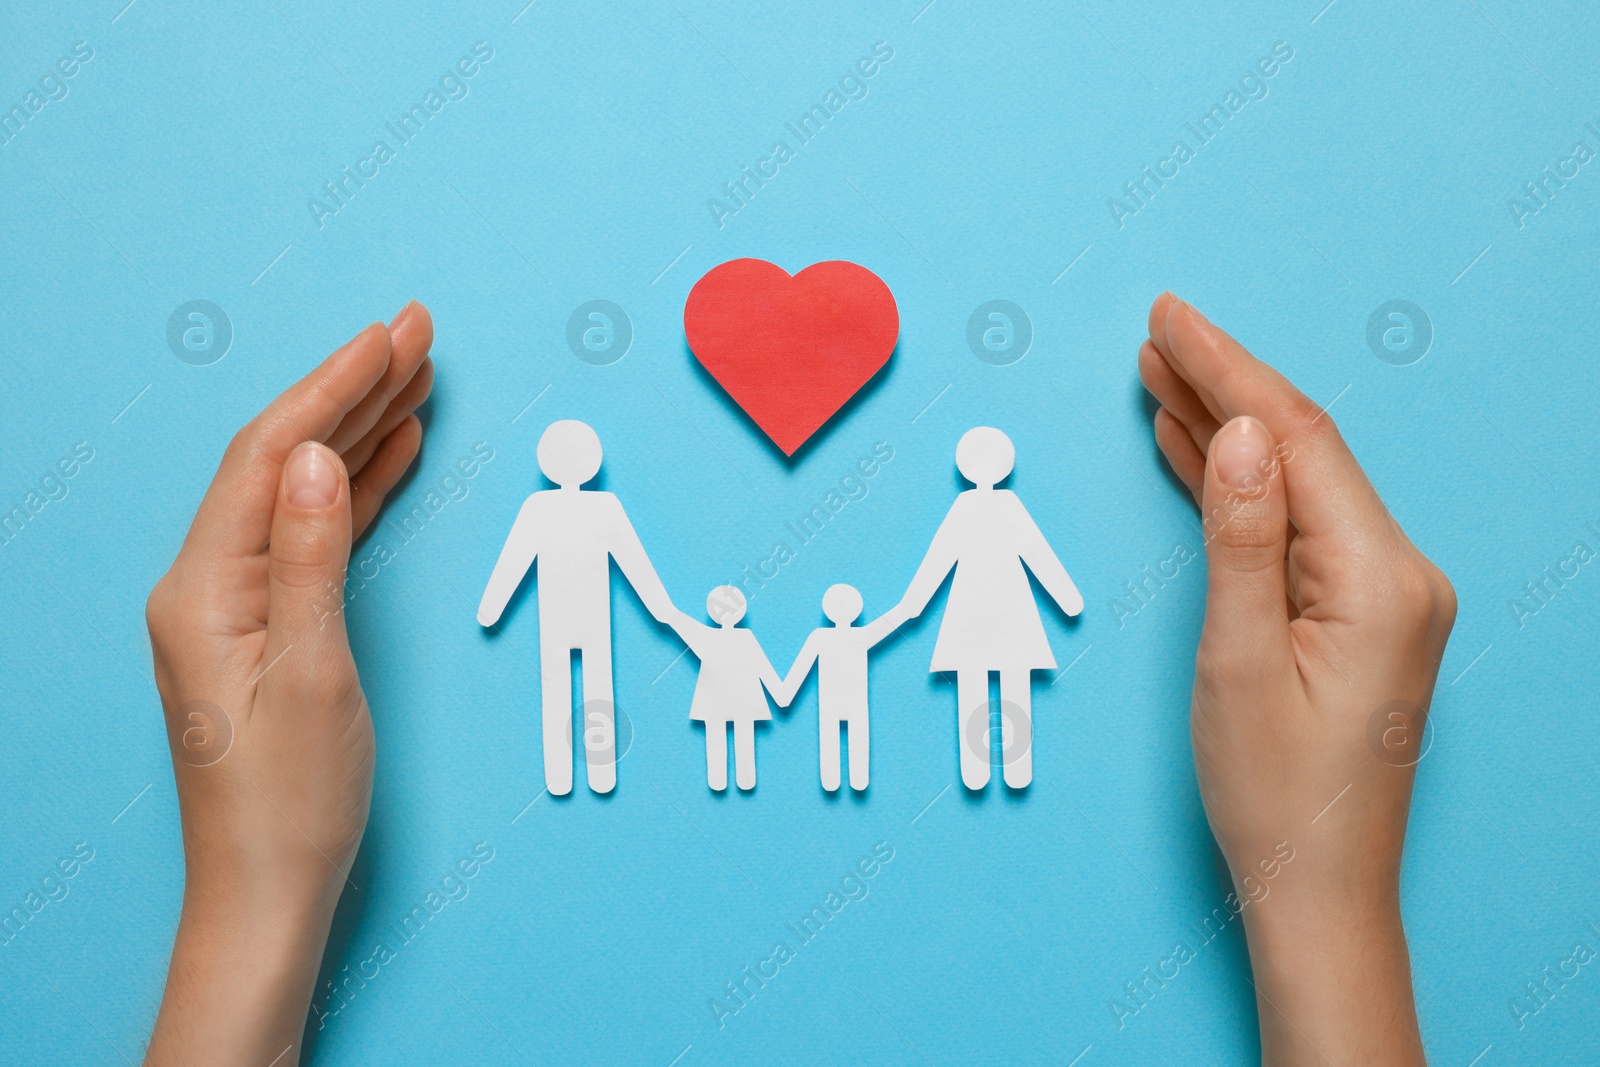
[{"x1": 184, "y1": 323, "x2": 389, "y2": 555}]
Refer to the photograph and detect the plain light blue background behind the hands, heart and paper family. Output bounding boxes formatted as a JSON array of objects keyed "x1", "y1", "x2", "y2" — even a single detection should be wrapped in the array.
[{"x1": 0, "y1": 0, "x2": 1600, "y2": 1067}]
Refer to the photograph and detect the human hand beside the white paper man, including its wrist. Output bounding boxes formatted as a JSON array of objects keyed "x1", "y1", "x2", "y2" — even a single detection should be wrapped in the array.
[{"x1": 146, "y1": 302, "x2": 434, "y2": 1064}]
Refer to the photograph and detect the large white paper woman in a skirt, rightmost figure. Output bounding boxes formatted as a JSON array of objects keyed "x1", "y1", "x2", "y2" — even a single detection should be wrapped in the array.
[{"x1": 896, "y1": 426, "x2": 1083, "y2": 789}]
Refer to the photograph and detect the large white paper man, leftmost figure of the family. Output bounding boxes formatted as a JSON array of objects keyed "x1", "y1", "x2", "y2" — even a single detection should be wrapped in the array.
[{"x1": 478, "y1": 419, "x2": 677, "y2": 795}]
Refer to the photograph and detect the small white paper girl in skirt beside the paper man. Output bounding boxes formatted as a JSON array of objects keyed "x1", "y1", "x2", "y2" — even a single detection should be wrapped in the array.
[{"x1": 672, "y1": 585, "x2": 782, "y2": 792}]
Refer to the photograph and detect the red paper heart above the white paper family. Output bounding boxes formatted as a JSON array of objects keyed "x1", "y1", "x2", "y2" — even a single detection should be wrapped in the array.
[{"x1": 683, "y1": 259, "x2": 899, "y2": 456}]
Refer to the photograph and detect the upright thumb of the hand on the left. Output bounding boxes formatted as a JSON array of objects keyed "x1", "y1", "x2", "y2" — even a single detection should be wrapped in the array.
[{"x1": 262, "y1": 442, "x2": 350, "y2": 667}]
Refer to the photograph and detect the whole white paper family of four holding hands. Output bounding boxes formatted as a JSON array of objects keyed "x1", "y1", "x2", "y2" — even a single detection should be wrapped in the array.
[{"x1": 478, "y1": 419, "x2": 1083, "y2": 795}]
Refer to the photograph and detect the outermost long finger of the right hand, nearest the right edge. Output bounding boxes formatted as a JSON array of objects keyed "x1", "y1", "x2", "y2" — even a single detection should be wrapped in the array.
[{"x1": 1165, "y1": 299, "x2": 1390, "y2": 537}]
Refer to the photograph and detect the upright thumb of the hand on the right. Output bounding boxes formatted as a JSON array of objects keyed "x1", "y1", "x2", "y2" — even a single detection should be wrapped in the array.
[{"x1": 1200, "y1": 416, "x2": 1290, "y2": 672}]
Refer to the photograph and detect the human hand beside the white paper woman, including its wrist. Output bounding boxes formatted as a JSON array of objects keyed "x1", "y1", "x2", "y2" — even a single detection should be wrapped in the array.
[{"x1": 1139, "y1": 293, "x2": 1456, "y2": 1064}]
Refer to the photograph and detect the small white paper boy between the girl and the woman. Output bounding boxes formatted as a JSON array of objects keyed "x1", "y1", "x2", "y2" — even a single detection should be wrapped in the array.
[{"x1": 773, "y1": 585, "x2": 907, "y2": 792}]
